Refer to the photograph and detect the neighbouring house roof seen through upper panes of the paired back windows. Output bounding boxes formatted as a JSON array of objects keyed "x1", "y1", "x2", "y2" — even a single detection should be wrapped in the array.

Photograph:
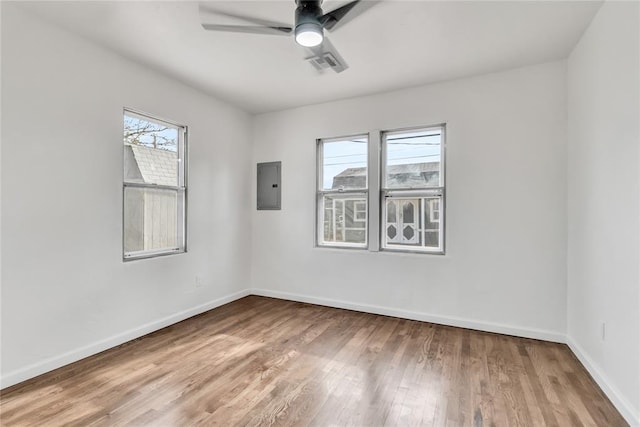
[{"x1": 331, "y1": 162, "x2": 440, "y2": 188}]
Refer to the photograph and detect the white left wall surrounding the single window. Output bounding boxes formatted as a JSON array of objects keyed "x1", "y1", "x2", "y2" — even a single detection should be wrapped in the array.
[{"x1": 2, "y1": 2, "x2": 251, "y2": 387}]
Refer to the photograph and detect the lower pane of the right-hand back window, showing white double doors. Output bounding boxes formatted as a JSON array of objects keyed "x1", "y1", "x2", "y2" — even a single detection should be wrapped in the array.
[{"x1": 383, "y1": 196, "x2": 442, "y2": 250}]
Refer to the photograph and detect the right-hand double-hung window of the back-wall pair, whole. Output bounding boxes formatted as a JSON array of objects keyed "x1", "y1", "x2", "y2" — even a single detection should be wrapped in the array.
[{"x1": 380, "y1": 126, "x2": 444, "y2": 253}]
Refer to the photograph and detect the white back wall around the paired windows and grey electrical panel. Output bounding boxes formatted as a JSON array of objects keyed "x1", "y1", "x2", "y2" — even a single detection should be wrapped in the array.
[{"x1": 252, "y1": 62, "x2": 567, "y2": 341}]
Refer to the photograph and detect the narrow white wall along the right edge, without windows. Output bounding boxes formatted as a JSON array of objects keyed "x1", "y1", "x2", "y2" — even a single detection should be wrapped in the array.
[{"x1": 567, "y1": 2, "x2": 640, "y2": 425}]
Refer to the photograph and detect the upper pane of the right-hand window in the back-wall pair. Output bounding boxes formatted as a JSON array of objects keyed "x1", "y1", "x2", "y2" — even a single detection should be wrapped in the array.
[{"x1": 384, "y1": 128, "x2": 443, "y2": 189}]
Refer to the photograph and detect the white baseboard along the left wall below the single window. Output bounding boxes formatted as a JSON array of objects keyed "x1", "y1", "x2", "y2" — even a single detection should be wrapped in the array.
[{"x1": 0, "y1": 290, "x2": 250, "y2": 389}]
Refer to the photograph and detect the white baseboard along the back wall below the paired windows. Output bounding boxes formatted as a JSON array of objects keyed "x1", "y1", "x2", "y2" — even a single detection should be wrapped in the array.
[{"x1": 250, "y1": 288, "x2": 566, "y2": 344}]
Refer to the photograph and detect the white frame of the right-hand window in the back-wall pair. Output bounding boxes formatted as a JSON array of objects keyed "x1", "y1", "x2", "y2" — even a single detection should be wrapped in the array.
[{"x1": 378, "y1": 123, "x2": 446, "y2": 255}]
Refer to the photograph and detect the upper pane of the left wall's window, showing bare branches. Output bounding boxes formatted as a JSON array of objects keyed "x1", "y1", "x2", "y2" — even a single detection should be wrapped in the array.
[{"x1": 124, "y1": 114, "x2": 181, "y2": 186}]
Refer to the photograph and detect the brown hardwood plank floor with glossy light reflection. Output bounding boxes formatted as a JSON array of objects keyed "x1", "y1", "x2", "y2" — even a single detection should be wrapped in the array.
[{"x1": 0, "y1": 296, "x2": 627, "y2": 427}]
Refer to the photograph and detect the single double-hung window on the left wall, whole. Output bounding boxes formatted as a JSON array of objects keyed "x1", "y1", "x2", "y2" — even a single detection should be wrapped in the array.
[{"x1": 123, "y1": 110, "x2": 187, "y2": 260}]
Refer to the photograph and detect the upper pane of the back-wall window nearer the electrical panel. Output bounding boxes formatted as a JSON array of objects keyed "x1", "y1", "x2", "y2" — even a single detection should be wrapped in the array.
[{"x1": 320, "y1": 136, "x2": 368, "y2": 190}]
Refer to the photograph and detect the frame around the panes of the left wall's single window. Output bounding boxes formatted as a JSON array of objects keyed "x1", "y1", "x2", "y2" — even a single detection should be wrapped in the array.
[{"x1": 121, "y1": 107, "x2": 189, "y2": 262}]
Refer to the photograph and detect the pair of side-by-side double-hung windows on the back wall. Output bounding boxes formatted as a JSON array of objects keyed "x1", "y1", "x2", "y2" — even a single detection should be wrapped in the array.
[{"x1": 316, "y1": 125, "x2": 445, "y2": 254}]
